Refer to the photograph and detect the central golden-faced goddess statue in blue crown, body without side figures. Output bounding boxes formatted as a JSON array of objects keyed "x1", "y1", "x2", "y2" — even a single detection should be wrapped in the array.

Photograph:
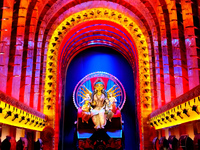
[{"x1": 91, "y1": 79, "x2": 107, "y2": 129}]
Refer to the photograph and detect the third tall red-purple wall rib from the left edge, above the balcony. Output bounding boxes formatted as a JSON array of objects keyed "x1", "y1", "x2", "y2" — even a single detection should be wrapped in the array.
[{"x1": 20, "y1": 2, "x2": 37, "y2": 109}]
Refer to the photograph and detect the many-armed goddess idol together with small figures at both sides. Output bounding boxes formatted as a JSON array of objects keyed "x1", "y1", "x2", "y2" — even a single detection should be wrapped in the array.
[{"x1": 78, "y1": 78, "x2": 121, "y2": 129}]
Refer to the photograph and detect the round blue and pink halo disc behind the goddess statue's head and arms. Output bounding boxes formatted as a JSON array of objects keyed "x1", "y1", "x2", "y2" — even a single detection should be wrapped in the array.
[{"x1": 73, "y1": 71, "x2": 126, "y2": 110}]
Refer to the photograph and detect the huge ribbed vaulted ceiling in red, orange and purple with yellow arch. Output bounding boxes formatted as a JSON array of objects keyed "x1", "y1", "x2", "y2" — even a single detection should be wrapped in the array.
[{"x1": 0, "y1": 0, "x2": 199, "y2": 150}]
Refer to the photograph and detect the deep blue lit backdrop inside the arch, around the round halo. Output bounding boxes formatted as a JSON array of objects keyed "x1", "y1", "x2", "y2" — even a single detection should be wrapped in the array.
[{"x1": 60, "y1": 47, "x2": 139, "y2": 150}]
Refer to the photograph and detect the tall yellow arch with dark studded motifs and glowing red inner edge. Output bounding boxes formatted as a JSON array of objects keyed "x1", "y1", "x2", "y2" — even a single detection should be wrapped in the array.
[{"x1": 44, "y1": 8, "x2": 151, "y2": 150}]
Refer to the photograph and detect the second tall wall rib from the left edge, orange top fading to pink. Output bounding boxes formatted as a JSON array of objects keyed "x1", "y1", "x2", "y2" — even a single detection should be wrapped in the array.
[{"x1": 10, "y1": 1, "x2": 29, "y2": 102}]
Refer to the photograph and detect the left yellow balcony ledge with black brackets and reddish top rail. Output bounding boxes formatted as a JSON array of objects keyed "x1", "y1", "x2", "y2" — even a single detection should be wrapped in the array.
[{"x1": 0, "y1": 92, "x2": 46, "y2": 131}]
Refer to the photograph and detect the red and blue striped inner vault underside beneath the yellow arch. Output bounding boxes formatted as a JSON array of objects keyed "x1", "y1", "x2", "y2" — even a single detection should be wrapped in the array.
[{"x1": 60, "y1": 20, "x2": 137, "y2": 68}]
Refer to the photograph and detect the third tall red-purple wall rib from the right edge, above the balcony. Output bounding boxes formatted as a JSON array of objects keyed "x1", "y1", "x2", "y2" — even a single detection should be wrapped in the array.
[{"x1": 160, "y1": 0, "x2": 176, "y2": 106}]
